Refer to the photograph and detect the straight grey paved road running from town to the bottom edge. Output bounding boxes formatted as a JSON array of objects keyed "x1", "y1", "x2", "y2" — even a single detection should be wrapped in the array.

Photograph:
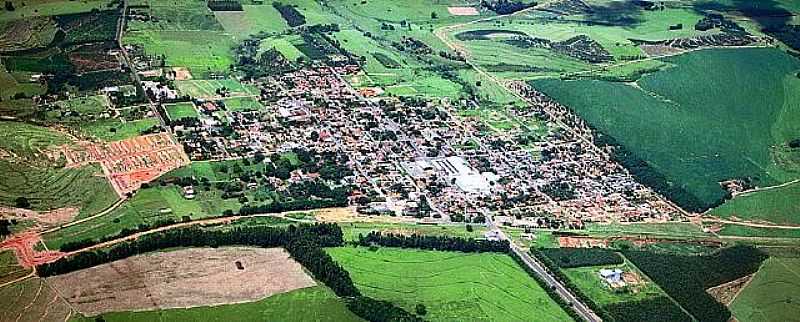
[{"x1": 486, "y1": 216, "x2": 602, "y2": 322}]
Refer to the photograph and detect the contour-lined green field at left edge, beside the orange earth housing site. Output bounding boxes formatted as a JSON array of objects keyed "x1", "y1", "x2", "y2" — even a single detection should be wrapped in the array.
[{"x1": 0, "y1": 122, "x2": 117, "y2": 214}]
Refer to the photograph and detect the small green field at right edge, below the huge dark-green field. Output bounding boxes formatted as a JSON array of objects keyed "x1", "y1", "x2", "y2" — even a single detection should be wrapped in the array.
[{"x1": 709, "y1": 183, "x2": 800, "y2": 224}]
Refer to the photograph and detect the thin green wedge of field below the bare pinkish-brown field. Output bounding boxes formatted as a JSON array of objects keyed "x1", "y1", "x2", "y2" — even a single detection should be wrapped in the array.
[{"x1": 70, "y1": 286, "x2": 363, "y2": 322}]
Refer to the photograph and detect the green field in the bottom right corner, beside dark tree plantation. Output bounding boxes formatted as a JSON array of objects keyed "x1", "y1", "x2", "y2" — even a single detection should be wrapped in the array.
[{"x1": 730, "y1": 257, "x2": 800, "y2": 322}]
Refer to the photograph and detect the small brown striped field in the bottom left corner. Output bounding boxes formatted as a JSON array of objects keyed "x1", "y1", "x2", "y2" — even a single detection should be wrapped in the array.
[{"x1": 0, "y1": 278, "x2": 72, "y2": 322}]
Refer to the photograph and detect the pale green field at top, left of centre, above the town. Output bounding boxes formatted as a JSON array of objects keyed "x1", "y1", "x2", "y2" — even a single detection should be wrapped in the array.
[{"x1": 214, "y1": 3, "x2": 289, "y2": 39}]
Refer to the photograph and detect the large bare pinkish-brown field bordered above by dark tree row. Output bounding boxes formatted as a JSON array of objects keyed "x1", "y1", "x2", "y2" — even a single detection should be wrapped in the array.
[{"x1": 47, "y1": 247, "x2": 316, "y2": 316}]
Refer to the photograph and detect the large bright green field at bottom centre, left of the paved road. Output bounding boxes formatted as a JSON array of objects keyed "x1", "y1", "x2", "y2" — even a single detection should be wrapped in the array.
[{"x1": 328, "y1": 247, "x2": 570, "y2": 321}]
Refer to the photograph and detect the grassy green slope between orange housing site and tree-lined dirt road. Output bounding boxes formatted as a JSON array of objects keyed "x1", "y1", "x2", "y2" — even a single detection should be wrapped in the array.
[{"x1": 43, "y1": 186, "x2": 241, "y2": 249}]
